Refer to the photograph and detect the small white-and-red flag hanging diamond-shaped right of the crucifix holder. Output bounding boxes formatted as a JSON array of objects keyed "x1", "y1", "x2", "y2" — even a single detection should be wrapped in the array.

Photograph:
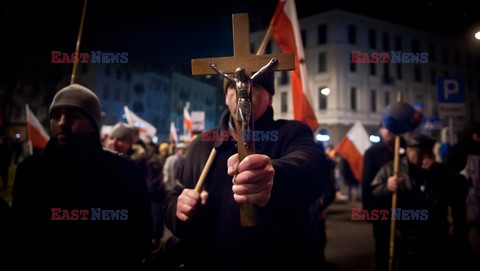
[{"x1": 335, "y1": 121, "x2": 372, "y2": 181}]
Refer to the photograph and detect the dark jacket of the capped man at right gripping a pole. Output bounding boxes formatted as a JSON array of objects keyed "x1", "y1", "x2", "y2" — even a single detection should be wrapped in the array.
[{"x1": 372, "y1": 157, "x2": 467, "y2": 270}]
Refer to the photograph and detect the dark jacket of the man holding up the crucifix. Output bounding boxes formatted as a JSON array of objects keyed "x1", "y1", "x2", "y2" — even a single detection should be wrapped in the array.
[{"x1": 166, "y1": 108, "x2": 331, "y2": 270}]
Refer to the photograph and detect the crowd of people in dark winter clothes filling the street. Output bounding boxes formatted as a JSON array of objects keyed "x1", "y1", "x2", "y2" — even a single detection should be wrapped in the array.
[{"x1": 0, "y1": 76, "x2": 480, "y2": 270}]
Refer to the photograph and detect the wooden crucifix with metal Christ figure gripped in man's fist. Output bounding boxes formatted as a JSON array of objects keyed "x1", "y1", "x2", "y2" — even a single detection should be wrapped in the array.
[{"x1": 192, "y1": 13, "x2": 295, "y2": 227}]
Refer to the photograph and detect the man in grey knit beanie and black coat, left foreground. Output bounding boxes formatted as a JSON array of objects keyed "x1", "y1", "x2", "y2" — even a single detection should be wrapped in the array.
[{"x1": 12, "y1": 84, "x2": 152, "y2": 267}]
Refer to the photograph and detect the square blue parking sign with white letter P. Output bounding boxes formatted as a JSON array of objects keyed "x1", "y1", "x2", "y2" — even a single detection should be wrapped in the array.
[{"x1": 437, "y1": 76, "x2": 465, "y2": 103}]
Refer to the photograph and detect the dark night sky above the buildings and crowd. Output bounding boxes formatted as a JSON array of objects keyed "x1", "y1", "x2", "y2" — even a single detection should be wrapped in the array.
[{"x1": 0, "y1": 0, "x2": 480, "y2": 70}]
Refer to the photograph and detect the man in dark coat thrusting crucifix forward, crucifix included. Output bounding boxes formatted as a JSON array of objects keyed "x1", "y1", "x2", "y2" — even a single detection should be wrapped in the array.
[{"x1": 166, "y1": 14, "x2": 331, "y2": 270}]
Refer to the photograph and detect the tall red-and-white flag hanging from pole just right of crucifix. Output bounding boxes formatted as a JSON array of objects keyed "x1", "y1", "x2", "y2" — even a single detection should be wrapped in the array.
[{"x1": 270, "y1": 0, "x2": 318, "y2": 131}]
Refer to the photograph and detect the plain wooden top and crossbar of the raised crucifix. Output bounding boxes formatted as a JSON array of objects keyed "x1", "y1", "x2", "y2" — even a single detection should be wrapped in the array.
[{"x1": 192, "y1": 13, "x2": 295, "y2": 76}]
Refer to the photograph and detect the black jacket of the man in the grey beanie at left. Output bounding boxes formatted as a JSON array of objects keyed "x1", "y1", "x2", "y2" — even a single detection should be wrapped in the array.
[{"x1": 12, "y1": 135, "x2": 151, "y2": 266}]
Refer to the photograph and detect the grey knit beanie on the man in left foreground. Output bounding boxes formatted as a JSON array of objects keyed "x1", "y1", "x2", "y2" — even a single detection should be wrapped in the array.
[{"x1": 48, "y1": 84, "x2": 102, "y2": 131}]
